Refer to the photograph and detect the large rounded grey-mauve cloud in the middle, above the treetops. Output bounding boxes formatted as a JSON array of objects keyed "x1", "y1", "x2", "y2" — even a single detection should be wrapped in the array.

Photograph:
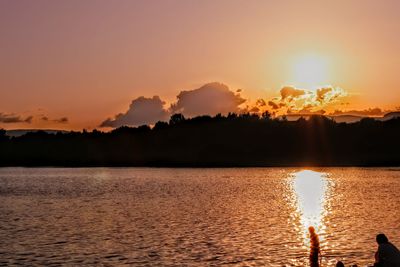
[{"x1": 171, "y1": 82, "x2": 246, "y2": 117}]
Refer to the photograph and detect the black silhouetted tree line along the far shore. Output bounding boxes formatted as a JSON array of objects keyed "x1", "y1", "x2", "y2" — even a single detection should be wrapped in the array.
[{"x1": 0, "y1": 113, "x2": 400, "y2": 167}]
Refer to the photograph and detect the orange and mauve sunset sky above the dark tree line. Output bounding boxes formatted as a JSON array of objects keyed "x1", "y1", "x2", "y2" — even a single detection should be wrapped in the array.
[{"x1": 0, "y1": 0, "x2": 400, "y2": 130}]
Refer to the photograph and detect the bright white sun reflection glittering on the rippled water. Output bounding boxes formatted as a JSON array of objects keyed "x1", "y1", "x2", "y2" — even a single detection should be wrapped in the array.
[{"x1": 292, "y1": 170, "x2": 328, "y2": 246}]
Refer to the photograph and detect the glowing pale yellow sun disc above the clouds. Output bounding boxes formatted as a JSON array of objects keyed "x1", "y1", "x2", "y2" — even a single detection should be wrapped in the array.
[{"x1": 290, "y1": 53, "x2": 329, "y2": 90}]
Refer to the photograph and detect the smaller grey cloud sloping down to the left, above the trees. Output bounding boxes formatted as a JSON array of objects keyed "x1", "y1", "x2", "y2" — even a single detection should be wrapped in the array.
[{"x1": 100, "y1": 96, "x2": 169, "y2": 128}]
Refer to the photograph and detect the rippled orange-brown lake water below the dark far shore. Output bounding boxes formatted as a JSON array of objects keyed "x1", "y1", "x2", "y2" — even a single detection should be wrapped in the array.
[{"x1": 0, "y1": 168, "x2": 400, "y2": 266}]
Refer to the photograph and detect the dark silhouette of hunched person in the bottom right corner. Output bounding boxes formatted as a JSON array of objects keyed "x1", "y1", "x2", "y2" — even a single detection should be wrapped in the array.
[{"x1": 374, "y1": 234, "x2": 400, "y2": 267}]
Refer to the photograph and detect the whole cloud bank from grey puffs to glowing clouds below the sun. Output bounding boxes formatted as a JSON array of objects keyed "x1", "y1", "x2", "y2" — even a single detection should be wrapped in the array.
[{"x1": 100, "y1": 82, "x2": 347, "y2": 128}]
